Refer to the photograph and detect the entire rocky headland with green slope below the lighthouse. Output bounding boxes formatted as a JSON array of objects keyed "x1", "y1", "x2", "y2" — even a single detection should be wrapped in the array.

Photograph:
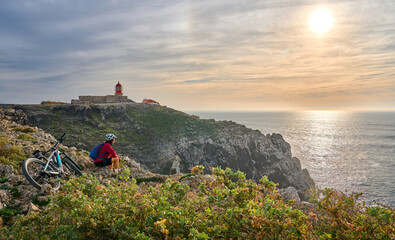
[{"x1": 0, "y1": 103, "x2": 314, "y2": 200}]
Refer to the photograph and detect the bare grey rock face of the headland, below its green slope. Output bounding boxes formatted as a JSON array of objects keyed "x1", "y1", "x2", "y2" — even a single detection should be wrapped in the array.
[{"x1": 152, "y1": 122, "x2": 314, "y2": 200}]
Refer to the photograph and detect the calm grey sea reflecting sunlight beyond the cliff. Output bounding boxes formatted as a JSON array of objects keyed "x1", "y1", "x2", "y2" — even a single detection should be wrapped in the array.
[{"x1": 188, "y1": 111, "x2": 395, "y2": 207}]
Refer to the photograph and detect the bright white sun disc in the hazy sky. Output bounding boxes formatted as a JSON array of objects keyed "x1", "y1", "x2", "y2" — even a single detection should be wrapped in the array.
[{"x1": 309, "y1": 9, "x2": 333, "y2": 35}]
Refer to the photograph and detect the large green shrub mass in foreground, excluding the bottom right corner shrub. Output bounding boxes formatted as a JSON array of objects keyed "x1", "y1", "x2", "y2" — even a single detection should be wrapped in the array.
[{"x1": 3, "y1": 169, "x2": 308, "y2": 239}]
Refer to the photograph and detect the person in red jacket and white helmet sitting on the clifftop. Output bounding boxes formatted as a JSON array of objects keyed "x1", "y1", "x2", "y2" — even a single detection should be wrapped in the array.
[{"x1": 94, "y1": 133, "x2": 119, "y2": 174}]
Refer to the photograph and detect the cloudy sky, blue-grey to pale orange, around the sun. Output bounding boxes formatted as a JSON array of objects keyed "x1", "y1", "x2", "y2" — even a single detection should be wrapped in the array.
[{"x1": 0, "y1": 0, "x2": 395, "y2": 111}]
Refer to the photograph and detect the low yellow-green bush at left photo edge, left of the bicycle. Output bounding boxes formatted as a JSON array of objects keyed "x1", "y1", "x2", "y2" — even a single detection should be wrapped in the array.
[{"x1": 0, "y1": 134, "x2": 27, "y2": 169}]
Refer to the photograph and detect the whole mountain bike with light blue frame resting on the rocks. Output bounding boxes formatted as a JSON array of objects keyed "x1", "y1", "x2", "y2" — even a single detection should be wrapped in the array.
[{"x1": 22, "y1": 133, "x2": 82, "y2": 190}]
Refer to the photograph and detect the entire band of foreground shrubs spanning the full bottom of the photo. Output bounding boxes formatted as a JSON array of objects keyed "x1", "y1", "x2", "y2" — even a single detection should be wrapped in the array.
[{"x1": 0, "y1": 168, "x2": 395, "y2": 239}]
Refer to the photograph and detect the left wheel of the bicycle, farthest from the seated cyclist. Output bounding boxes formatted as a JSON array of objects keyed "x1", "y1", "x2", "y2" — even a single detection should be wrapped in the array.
[{"x1": 22, "y1": 158, "x2": 60, "y2": 190}]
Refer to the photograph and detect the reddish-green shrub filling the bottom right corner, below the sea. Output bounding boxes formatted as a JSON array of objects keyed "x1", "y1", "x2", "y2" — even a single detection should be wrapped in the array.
[{"x1": 314, "y1": 189, "x2": 395, "y2": 239}]
